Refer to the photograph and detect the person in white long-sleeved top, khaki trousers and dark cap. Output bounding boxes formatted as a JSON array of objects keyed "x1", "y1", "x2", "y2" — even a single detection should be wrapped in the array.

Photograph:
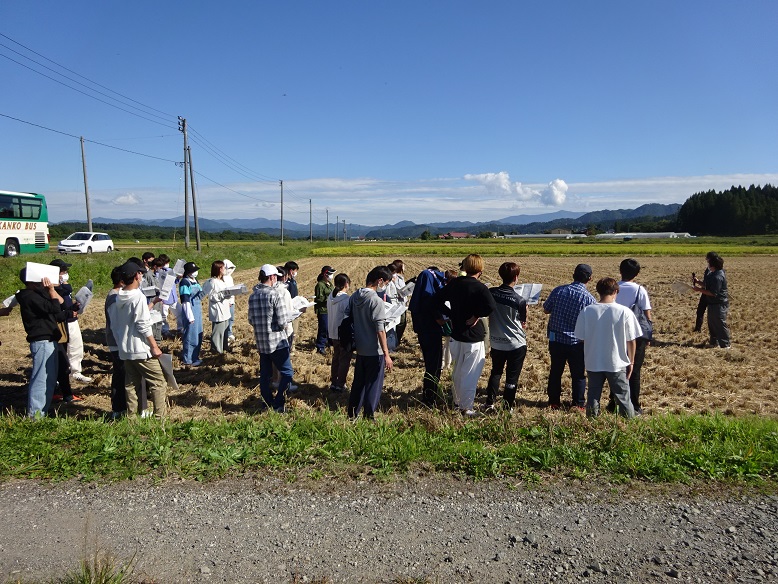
[{"x1": 108, "y1": 262, "x2": 167, "y2": 418}]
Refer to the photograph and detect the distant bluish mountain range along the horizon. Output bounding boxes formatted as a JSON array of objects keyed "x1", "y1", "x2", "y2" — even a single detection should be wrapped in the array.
[{"x1": 62, "y1": 203, "x2": 681, "y2": 239}]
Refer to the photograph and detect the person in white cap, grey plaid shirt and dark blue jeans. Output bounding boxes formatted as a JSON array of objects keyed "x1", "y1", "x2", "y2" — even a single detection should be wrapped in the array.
[{"x1": 249, "y1": 264, "x2": 294, "y2": 413}]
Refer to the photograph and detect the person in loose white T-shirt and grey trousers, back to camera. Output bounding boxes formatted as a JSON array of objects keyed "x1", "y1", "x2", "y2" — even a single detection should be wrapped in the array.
[{"x1": 575, "y1": 278, "x2": 642, "y2": 418}]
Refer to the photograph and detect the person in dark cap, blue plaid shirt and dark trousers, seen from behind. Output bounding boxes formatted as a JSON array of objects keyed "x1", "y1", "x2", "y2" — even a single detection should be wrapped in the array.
[{"x1": 543, "y1": 264, "x2": 597, "y2": 410}]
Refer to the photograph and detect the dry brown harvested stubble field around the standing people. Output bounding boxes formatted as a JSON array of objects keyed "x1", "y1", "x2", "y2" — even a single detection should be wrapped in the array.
[{"x1": 0, "y1": 256, "x2": 778, "y2": 420}]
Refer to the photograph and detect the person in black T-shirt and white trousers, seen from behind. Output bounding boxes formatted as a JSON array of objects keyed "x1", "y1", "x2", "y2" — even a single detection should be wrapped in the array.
[{"x1": 433, "y1": 254, "x2": 495, "y2": 416}]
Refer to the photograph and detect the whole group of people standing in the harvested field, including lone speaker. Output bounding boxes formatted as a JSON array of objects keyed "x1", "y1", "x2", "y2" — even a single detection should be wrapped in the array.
[{"x1": 10, "y1": 252, "x2": 730, "y2": 418}]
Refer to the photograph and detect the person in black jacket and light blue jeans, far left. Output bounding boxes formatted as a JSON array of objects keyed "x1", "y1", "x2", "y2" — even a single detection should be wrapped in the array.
[{"x1": 16, "y1": 268, "x2": 73, "y2": 418}]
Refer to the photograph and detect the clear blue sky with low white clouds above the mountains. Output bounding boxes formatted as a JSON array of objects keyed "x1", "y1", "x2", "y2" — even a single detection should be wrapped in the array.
[{"x1": 0, "y1": 0, "x2": 778, "y2": 225}]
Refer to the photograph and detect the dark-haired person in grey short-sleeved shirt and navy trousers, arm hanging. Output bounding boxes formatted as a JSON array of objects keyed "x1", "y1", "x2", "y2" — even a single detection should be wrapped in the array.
[{"x1": 344, "y1": 266, "x2": 392, "y2": 420}]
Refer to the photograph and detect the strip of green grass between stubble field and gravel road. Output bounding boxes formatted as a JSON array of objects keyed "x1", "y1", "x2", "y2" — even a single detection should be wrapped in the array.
[{"x1": 0, "y1": 411, "x2": 778, "y2": 485}]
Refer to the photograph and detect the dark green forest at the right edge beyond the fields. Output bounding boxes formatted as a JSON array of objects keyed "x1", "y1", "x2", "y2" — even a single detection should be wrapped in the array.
[{"x1": 678, "y1": 184, "x2": 778, "y2": 236}]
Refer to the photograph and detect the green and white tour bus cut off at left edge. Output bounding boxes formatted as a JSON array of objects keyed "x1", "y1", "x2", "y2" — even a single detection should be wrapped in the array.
[{"x1": 0, "y1": 191, "x2": 49, "y2": 257}]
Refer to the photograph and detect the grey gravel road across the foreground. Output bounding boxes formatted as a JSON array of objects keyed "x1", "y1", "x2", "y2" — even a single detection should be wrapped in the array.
[{"x1": 0, "y1": 477, "x2": 778, "y2": 584}]
